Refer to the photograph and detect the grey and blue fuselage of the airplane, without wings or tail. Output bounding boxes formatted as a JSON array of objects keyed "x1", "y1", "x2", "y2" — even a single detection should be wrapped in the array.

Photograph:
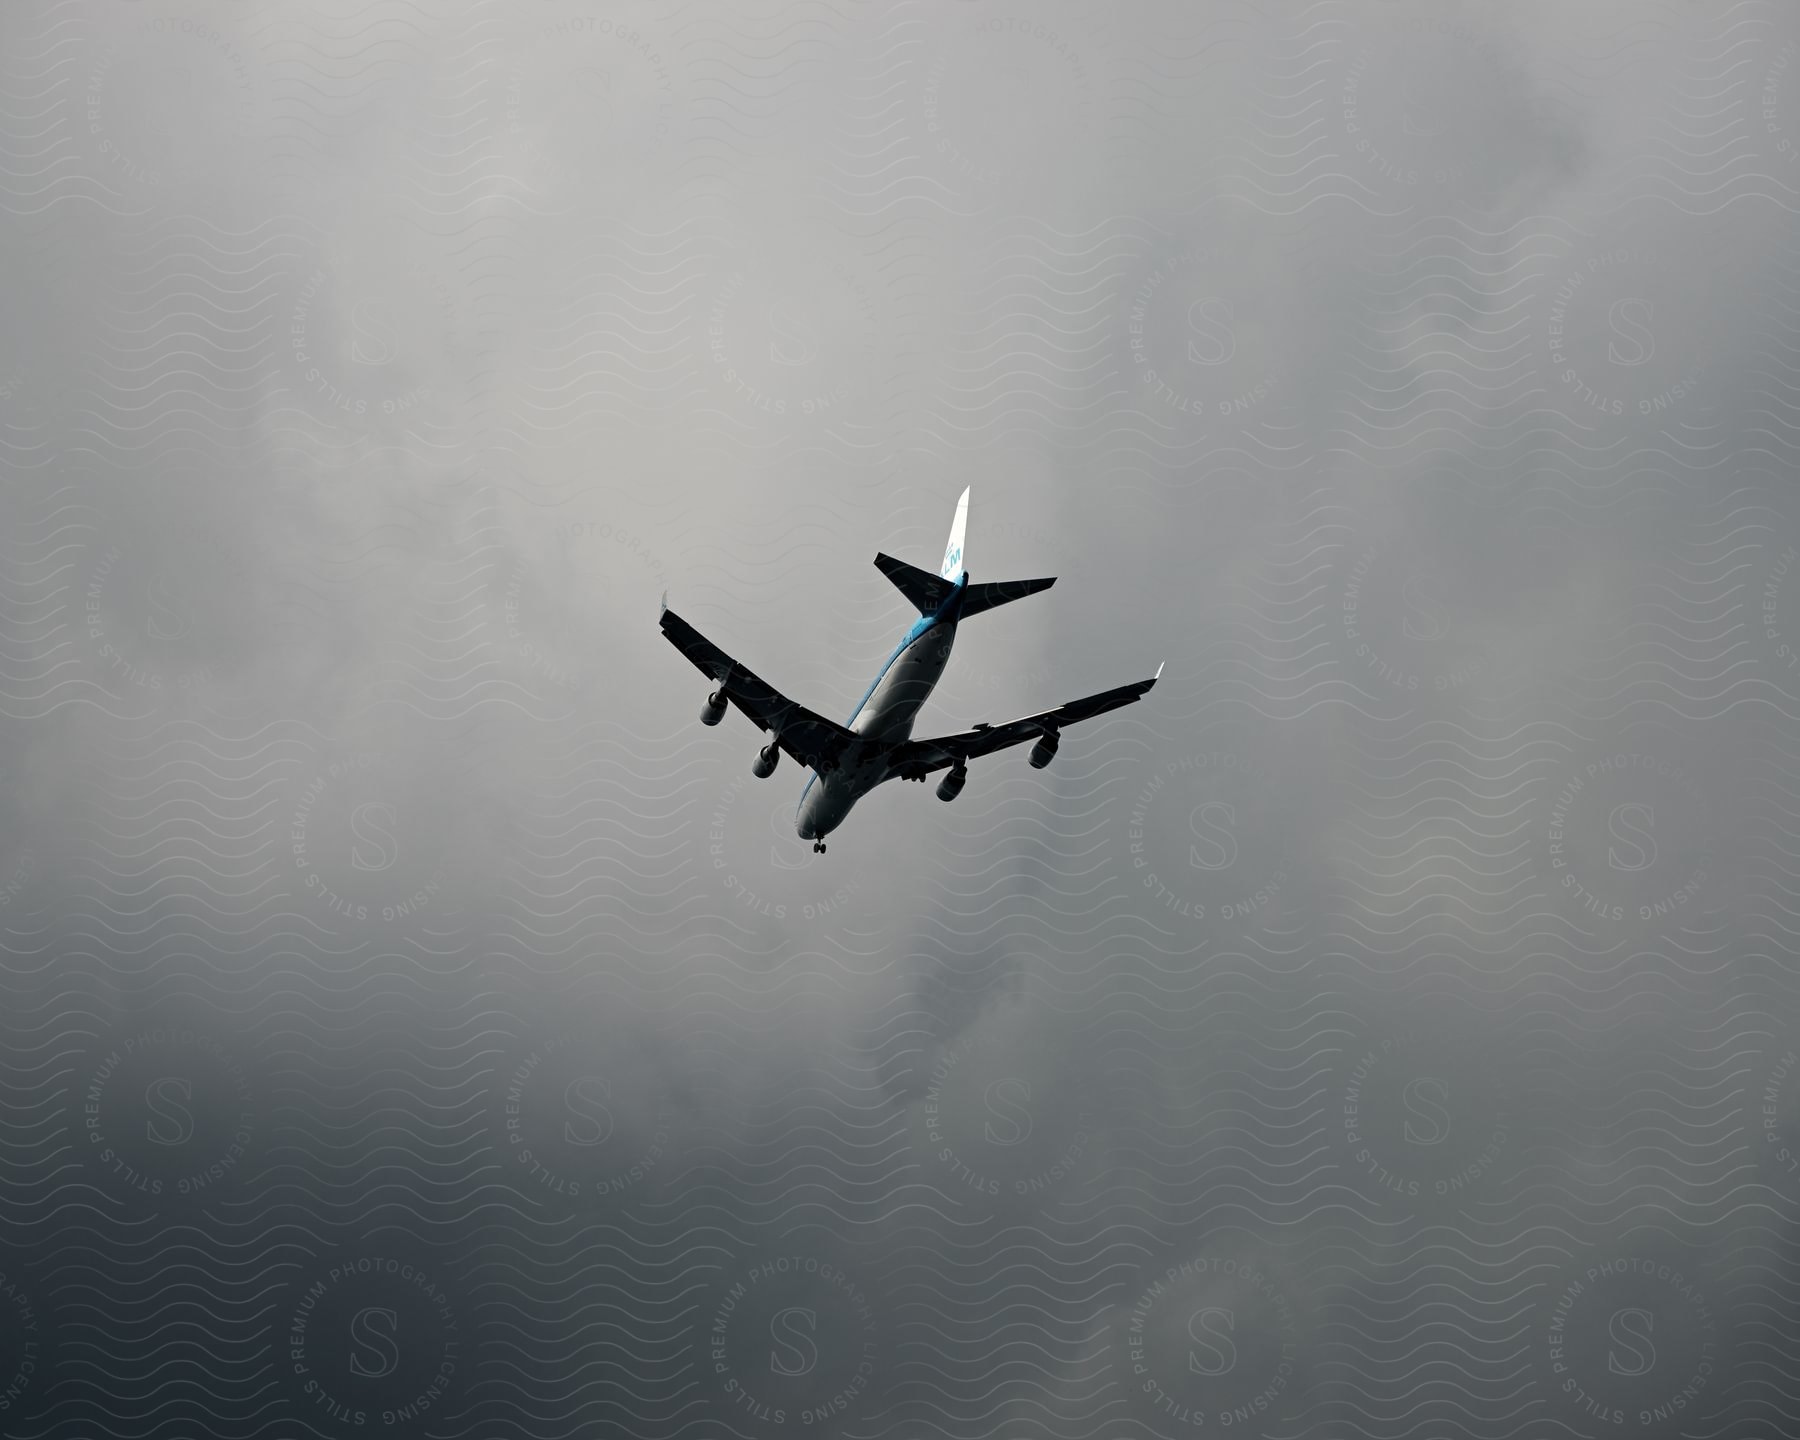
[{"x1": 794, "y1": 572, "x2": 968, "y2": 841}]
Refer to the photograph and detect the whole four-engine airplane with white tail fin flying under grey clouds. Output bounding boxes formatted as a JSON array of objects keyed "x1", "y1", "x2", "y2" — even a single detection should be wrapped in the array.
[{"x1": 661, "y1": 490, "x2": 1163, "y2": 855}]
